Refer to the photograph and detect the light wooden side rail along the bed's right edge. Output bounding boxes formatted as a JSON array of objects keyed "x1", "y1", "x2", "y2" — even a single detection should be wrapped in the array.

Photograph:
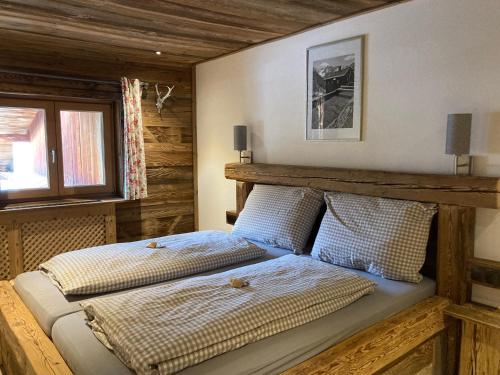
[{"x1": 283, "y1": 297, "x2": 450, "y2": 375}]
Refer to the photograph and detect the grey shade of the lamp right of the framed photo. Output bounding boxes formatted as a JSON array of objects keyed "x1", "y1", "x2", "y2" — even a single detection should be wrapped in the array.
[{"x1": 446, "y1": 113, "x2": 472, "y2": 155}]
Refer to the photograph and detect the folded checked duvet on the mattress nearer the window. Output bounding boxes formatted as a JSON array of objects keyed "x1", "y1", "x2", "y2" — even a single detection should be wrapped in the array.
[{"x1": 39, "y1": 231, "x2": 265, "y2": 295}]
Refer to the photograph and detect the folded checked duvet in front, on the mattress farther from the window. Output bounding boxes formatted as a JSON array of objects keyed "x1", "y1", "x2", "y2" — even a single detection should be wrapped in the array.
[{"x1": 82, "y1": 255, "x2": 375, "y2": 374}]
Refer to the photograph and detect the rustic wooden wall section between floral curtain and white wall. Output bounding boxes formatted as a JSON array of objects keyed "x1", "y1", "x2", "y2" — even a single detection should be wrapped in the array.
[{"x1": 116, "y1": 69, "x2": 195, "y2": 242}]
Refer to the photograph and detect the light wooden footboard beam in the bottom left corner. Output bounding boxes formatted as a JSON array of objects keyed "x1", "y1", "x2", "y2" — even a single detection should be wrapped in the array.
[{"x1": 0, "y1": 281, "x2": 71, "y2": 375}]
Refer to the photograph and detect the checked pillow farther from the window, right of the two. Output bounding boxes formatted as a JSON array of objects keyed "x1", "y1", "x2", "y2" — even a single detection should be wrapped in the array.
[{"x1": 311, "y1": 192, "x2": 437, "y2": 283}]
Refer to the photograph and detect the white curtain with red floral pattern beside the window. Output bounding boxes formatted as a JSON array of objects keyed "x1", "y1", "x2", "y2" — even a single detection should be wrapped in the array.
[{"x1": 122, "y1": 77, "x2": 148, "y2": 200}]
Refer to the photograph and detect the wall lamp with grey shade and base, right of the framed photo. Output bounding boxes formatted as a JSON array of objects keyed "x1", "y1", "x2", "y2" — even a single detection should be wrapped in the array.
[{"x1": 446, "y1": 113, "x2": 472, "y2": 175}]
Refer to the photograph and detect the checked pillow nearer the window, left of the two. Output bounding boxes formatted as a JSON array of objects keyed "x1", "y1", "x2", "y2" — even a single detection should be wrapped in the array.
[{"x1": 233, "y1": 185, "x2": 323, "y2": 254}]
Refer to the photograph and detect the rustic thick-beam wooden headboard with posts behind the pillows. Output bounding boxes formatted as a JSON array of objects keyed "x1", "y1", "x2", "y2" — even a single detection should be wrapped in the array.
[{"x1": 225, "y1": 163, "x2": 500, "y2": 304}]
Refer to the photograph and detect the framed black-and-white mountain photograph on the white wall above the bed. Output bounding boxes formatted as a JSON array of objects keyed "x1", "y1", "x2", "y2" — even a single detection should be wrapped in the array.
[{"x1": 306, "y1": 36, "x2": 364, "y2": 141}]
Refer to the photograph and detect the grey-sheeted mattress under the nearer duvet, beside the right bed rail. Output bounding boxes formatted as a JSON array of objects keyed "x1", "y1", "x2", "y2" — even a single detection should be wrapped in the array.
[{"x1": 52, "y1": 271, "x2": 435, "y2": 375}]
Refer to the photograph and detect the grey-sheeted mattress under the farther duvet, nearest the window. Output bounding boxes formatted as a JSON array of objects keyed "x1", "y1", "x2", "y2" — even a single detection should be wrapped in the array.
[{"x1": 14, "y1": 242, "x2": 291, "y2": 336}]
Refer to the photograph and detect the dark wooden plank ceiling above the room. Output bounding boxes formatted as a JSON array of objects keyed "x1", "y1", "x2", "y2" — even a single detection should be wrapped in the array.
[{"x1": 0, "y1": 0, "x2": 401, "y2": 79}]
